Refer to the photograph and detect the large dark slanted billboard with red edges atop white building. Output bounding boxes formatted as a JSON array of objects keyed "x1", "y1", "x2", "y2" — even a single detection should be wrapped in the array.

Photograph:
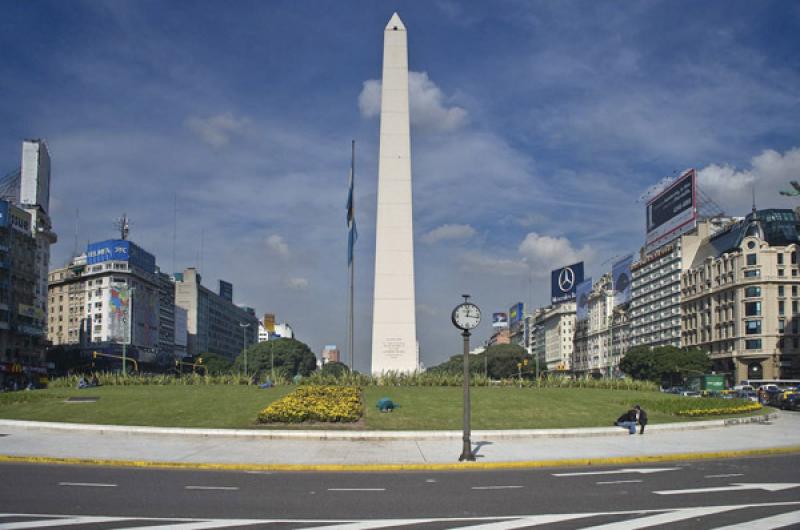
[{"x1": 645, "y1": 169, "x2": 697, "y2": 252}]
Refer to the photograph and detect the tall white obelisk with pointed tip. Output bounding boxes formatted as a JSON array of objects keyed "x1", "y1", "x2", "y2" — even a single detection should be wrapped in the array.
[{"x1": 372, "y1": 13, "x2": 419, "y2": 374}]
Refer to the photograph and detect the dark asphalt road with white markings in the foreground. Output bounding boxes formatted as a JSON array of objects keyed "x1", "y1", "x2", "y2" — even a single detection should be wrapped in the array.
[{"x1": 0, "y1": 455, "x2": 800, "y2": 530}]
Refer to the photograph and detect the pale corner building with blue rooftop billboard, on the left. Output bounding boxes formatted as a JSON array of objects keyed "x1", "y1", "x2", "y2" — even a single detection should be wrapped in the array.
[{"x1": 48, "y1": 234, "x2": 164, "y2": 363}]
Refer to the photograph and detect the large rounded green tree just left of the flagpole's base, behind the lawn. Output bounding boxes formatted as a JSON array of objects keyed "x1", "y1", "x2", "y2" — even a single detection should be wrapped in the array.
[{"x1": 233, "y1": 338, "x2": 317, "y2": 377}]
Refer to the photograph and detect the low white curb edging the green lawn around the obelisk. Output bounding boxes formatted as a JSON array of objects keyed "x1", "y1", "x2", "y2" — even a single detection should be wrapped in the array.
[{"x1": 0, "y1": 412, "x2": 778, "y2": 441}]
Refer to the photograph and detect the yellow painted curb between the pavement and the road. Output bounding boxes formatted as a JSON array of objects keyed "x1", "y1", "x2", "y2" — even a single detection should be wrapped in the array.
[{"x1": 0, "y1": 445, "x2": 800, "y2": 472}]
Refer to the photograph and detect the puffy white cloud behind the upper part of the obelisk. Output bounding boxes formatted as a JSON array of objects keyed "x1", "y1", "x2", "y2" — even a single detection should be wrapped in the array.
[{"x1": 358, "y1": 72, "x2": 467, "y2": 132}]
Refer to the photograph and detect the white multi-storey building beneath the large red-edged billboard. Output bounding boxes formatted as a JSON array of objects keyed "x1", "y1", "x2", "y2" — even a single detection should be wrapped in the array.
[{"x1": 626, "y1": 217, "x2": 732, "y2": 347}]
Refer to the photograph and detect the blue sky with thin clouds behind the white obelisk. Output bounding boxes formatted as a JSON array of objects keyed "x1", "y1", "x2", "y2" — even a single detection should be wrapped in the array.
[{"x1": 0, "y1": 0, "x2": 800, "y2": 369}]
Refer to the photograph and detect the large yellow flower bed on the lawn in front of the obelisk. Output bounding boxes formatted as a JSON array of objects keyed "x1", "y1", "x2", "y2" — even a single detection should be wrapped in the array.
[{"x1": 258, "y1": 386, "x2": 364, "y2": 423}]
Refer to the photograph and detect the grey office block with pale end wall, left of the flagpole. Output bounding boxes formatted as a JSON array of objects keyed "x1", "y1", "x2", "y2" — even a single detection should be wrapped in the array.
[{"x1": 175, "y1": 267, "x2": 259, "y2": 359}]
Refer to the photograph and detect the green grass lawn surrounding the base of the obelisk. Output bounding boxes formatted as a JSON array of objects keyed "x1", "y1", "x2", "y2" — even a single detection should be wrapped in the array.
[{"x1": 0, "y1": 385, "x2": 764, "y2": 430}]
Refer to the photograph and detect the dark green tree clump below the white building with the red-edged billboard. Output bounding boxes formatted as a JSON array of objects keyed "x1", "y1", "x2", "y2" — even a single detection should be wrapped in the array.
[{"x1": 619, "y1": 346, "x2": 711, "y2": 384}]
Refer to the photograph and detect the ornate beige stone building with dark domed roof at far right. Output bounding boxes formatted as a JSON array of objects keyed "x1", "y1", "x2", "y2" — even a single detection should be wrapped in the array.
[{"x1": 681, "y1": 207, "x2": 800, "y2": 382}]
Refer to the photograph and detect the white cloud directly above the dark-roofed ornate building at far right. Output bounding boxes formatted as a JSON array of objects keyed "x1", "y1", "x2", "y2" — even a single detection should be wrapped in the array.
[{"x1": 697, "y1": 147, "x2": 800, "y2": 211}]
